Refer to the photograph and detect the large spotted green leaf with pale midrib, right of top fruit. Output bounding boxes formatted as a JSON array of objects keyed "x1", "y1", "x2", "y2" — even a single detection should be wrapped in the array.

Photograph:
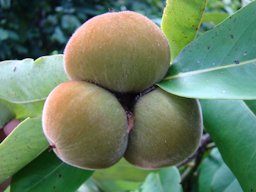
[{"x1": 159, "y1": 1, "x2": 256, "y2": 99}]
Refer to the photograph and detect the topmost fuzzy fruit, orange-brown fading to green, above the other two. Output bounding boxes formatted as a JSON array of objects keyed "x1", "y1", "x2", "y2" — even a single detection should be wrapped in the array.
[{"x1": 64, "y1": 11, "x2": 170, "y2": 92}]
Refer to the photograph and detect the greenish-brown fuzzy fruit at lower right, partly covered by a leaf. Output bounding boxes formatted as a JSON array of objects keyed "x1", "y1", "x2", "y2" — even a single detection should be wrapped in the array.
[{"x1": 125, "y1": 88, "x2": 202, "y2": 169}]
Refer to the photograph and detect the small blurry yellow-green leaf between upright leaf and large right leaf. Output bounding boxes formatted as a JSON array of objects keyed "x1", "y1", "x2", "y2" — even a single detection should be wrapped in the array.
[{"x1": 202, "y1": 12, "x2": 228, "y2": 25}]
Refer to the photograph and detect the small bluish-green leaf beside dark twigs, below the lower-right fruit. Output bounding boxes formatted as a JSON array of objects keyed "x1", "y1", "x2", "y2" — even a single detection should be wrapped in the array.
[{"x1": 198, "y1": 148, "x2": 222, "y2": 192}]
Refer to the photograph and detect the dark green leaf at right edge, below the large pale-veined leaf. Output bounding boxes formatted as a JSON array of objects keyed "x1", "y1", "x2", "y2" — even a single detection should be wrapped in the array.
[{"x1": 201, "y1": 100, "x2": 256, "y2": 191}]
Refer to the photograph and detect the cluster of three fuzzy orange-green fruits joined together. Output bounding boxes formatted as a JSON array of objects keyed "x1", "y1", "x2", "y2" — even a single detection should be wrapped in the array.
[{"x1": 43, "y1": 11, "x2": 202, "y2": 169}]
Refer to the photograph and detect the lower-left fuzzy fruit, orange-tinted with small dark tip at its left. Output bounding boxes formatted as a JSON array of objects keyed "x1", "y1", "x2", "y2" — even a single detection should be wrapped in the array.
[{"x1": 43, "y1": 81, "x2": 128, "y2": 169}]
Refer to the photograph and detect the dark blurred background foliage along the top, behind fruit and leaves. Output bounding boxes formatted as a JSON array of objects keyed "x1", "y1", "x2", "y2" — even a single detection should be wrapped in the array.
[{"x1": 0, "y1": 0, "x2": 240, "y2": 60}]
